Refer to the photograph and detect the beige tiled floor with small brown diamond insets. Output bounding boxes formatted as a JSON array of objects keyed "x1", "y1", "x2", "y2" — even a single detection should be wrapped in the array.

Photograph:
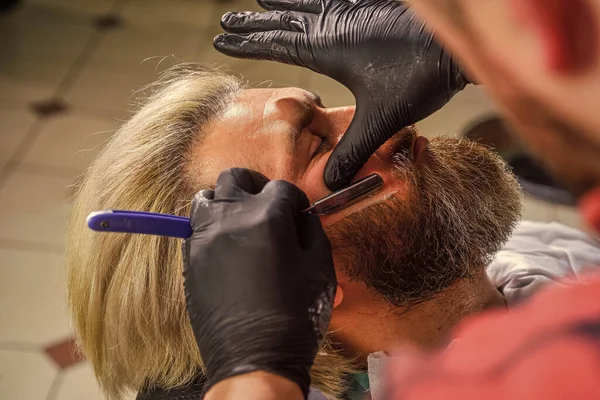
[{"x1": 0, "y1": 0, "x2": 579, "y2": 400}]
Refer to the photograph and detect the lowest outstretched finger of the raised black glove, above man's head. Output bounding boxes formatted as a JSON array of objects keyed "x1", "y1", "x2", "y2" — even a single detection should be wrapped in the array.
[{"x1": 213, "y1": 31, "x2": 302, "y2": 65}]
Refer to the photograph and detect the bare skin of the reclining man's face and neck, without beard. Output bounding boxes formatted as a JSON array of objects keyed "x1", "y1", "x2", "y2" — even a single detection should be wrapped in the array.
[{"x1": 192, "y1": 84, "x2": 504, "y2": 363}]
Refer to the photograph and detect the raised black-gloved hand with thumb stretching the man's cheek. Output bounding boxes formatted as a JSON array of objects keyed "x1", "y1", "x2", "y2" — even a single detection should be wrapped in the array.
[{"x1": 214, "y1": 0, "x2": 468, "y2": 190}]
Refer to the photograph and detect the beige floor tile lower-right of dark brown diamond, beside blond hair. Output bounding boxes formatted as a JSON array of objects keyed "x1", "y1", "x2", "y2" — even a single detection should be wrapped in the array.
[{"x1": 24, "y1": 114, "x2": 117, "y2": 176}]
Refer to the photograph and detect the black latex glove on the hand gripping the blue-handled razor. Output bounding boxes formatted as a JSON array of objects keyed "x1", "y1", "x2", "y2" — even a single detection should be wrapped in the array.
[{"x1": 183, "y1": 169, "x2": 337, "y2": 396}]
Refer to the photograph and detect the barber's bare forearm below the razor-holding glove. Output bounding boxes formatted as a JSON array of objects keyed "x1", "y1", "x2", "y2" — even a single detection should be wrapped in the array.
[{"x1": 204, "y1": 371, "x2": 304, "y2": 400}]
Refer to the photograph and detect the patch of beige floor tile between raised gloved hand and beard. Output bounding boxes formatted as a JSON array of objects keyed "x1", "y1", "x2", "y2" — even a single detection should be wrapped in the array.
[{"x1": 417, "y1": 85, "x2": 496, "y2": 137}]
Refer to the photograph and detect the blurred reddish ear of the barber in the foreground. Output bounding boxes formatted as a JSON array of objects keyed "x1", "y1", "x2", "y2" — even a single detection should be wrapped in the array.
[{"x1": 509, "y1": 0, "x2": 599, "y2": 74}]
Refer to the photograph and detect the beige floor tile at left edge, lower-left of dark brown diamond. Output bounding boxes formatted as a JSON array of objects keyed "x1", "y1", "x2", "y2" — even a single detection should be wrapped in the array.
[{"x1": 0, "y1": 108, "x2": 35, "y2": 169}]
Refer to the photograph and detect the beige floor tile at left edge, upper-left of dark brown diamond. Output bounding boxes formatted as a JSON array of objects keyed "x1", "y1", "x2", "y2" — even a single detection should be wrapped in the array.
[{"x1": 0, "y1": 59, "x2": 71, "y2": 104}]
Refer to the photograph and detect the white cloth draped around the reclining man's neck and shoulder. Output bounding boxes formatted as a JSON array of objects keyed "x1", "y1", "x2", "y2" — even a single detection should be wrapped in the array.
[{"x1": 367, "y1": 221, "x2": 600, "y2": 400}]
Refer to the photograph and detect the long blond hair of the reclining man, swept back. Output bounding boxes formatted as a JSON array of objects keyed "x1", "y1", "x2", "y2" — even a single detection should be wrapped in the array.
[{"x1": 66, "y1": 64, "x2": 353, "y2": 399}]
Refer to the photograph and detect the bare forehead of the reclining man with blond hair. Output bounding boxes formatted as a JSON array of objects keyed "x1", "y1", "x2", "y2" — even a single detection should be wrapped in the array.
[{"x1": 193, "y1": 87, "x2": 319, "y2": 185}]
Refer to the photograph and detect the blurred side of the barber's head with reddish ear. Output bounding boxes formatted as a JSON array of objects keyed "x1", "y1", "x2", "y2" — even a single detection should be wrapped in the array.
[{"x1": 409, "y1": 0, "x2": 600, "y2": 195}]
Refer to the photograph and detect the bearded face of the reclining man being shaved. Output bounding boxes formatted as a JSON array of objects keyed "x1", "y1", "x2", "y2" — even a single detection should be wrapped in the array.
[{"x1": 193, "y1": 88, "x2": 520, "y2": 305}]
